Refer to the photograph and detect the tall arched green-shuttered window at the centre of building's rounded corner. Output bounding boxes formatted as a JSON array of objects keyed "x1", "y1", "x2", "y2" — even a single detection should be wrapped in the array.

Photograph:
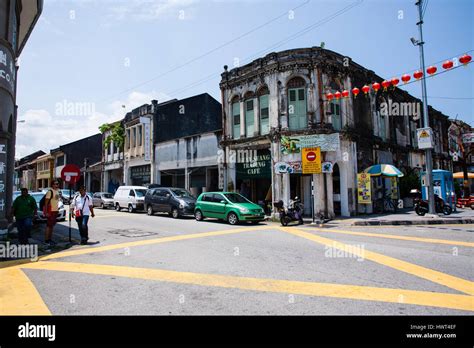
[{"x1": 287, "y1": 77, "x2": 308, "y2": 130}]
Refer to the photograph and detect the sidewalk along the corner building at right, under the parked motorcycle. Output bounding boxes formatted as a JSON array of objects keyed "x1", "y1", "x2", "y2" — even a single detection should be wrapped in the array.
[{"x1": 318, "y1": 208, "x2": 474, "y2": 226}]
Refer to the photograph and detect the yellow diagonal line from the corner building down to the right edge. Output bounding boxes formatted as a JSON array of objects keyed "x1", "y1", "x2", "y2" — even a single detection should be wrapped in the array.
[{"x1": 280, "y1": 227, "x2": 474, "y2": 295}]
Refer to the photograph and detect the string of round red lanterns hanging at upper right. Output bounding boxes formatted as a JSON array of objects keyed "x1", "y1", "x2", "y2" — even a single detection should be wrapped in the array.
[{"x1": 326, "y1": 53, "x2": 472, "y2": 101}]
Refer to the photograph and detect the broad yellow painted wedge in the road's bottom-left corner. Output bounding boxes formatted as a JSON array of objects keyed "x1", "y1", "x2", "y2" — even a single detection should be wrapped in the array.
[{"x1": 0, "y1": 268, "x2": 51, "y2": 315}]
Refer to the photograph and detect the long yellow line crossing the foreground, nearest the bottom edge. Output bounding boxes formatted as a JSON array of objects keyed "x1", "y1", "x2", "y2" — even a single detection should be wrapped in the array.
[{"x1": 22, "y1": 261, "x2": 474, "y2": 311}]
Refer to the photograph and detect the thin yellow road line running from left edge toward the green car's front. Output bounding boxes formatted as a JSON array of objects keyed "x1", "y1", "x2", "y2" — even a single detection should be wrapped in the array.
[{"x1": 0, "y1": 226, "x2": 273, "y2": 269}]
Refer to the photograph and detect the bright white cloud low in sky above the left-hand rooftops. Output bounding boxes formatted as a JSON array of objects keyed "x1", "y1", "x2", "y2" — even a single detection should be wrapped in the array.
[{"x1": 15, "y1": 91, "x2": 170, "y2": 158}]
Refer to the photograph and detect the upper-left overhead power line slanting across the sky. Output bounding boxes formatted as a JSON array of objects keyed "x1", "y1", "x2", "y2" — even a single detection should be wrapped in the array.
[{"x1": 99, "y1": 0, "x2": 309, "y2": 102}]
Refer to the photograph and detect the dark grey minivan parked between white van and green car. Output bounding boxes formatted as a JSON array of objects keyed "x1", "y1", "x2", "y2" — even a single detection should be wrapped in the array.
[{"x1": 145, "y1": 187, "x2": 196, "y2": 219}]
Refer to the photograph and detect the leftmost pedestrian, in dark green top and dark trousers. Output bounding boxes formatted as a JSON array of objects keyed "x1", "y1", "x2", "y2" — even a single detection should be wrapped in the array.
[{"x1": 12, "y1": 188, "x2": 38, "y2": 244}]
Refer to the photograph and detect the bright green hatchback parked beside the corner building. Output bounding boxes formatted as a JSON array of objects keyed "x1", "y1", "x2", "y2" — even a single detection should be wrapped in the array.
[{"x1": 194, "y1": 192, "x2": 265, "y2": 225}]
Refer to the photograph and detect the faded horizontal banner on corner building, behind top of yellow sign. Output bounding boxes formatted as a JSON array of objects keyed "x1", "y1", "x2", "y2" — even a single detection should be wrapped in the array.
[{"x1": 280, "y1": 133, "x2": 340, "y2": 155}]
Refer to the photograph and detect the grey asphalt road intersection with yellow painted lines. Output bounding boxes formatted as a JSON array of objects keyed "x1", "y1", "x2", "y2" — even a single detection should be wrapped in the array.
[{"x1": 0, "y1": 210, "x2": 474, "y2": 315}]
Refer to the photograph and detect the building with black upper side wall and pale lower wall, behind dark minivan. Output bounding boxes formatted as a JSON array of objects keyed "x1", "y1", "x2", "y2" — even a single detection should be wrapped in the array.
[{"x1": 154, "y1": 93, "x2": 222, "y2": 195}]
